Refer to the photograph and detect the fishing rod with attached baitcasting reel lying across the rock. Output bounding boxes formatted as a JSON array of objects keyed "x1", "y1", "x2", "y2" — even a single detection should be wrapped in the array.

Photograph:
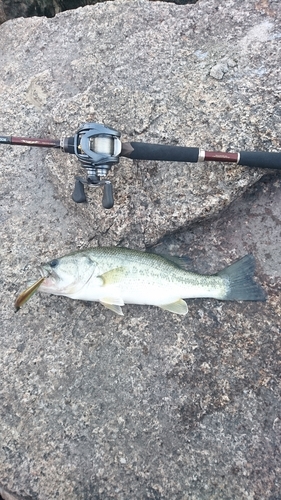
[{"x1": 0, "y1": 123, "x2": 281, "y2": 208}]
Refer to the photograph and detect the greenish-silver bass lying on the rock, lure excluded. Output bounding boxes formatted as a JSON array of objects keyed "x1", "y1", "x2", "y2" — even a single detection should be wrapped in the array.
[{"x1": 18, "y1": 247, "x2": 266, "y2": 315}]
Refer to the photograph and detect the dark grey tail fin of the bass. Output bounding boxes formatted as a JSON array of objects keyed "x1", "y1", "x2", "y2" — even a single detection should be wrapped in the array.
[{"x1": 218, "y1": 254, "x2": 266, "y2": 300}]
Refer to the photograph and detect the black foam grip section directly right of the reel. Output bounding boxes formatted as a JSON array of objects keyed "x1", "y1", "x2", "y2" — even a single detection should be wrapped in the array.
[{"x1": 126, "y1": 142, "x2": 199, "y2": 163}]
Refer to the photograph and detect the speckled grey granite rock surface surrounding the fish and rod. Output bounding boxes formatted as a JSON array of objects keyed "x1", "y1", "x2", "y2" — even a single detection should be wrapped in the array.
[{"x1": 0, "y1": 0, "x2": 281, "y2": 500}]
